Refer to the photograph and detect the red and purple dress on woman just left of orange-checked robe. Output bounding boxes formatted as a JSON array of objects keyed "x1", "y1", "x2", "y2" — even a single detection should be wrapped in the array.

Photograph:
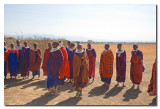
[{"x1": 86, "y1": 48, "x2": 96, "y2": 78}]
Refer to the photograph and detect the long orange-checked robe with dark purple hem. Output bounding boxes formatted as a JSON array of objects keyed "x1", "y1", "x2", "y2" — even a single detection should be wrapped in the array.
[{"x1": 99, "y1": 50, "x2": 114, "y2": 84}]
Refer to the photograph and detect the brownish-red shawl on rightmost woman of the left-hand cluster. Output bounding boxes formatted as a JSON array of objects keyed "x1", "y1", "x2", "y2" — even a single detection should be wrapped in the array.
[{"x1": 29, "y1": 48, "x2": 42, "y2": 72}]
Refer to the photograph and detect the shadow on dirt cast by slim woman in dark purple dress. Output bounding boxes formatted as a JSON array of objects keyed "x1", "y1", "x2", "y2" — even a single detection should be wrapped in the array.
[{"x1": 104, "y1": 86, "x2": 123, "y2": 98}]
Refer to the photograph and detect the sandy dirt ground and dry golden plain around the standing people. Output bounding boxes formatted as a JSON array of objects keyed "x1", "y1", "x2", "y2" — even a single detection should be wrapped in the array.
[{"x1": 4, "y1": 40, "x2": 157, "y2": 106}]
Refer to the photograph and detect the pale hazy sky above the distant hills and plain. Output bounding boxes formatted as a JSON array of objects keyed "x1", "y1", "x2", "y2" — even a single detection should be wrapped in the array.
[{"x1": 4, "y1": 4, "x2": 156, "y2": 42}]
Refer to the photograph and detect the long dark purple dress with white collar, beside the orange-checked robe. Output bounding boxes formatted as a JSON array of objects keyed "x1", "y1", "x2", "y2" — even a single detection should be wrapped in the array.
[{"x1": 116, "y1": 50, "x2": 126, "y2": 82}]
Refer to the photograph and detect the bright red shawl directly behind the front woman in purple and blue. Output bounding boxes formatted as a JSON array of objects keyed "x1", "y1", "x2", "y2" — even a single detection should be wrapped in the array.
[{"x1": 60, "y1": 47, "x2": 69, "y2": 79}]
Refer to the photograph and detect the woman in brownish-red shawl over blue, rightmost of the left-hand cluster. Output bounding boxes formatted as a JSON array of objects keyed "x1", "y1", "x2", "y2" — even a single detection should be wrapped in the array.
[{"x1": 29, "y1": 43, "x2": 42, "y2": 79}]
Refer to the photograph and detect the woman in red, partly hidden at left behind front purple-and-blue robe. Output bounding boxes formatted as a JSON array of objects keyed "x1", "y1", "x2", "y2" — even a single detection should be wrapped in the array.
[{"x1": 42, "y1": 43, "x2": 52, "y2": 76}]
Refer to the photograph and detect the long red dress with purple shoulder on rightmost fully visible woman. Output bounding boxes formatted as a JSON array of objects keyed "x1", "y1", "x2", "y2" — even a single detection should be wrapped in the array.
[{"x1": 130, "y1": 50, "x2": 144, "y2": 84}]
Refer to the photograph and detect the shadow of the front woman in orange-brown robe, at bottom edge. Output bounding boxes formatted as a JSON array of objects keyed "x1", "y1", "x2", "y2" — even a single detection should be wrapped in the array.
[{"x1": 56, "y1": 97, "x2": 82, "y2": 106}]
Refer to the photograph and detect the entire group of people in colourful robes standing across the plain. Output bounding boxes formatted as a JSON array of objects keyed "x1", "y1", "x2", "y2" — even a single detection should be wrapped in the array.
[{"x1": 4, "y1": 40, "x2": 156, "y2": 96}]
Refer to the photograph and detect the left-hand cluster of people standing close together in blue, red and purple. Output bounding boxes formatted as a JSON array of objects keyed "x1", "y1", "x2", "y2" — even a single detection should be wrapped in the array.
[{"x1": 4, "y1": 40, "x2": 42, "y2": 79}]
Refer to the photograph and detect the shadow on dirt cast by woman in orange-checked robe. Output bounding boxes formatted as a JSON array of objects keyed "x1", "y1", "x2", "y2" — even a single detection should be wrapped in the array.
[{"x1": 88, "y1": 85, "x2": 109, "y2": 97}]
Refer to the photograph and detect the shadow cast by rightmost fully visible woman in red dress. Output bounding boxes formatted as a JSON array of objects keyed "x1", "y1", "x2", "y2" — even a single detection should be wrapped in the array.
[{"x1": 123, "y1": 87, "x2": 142, "y2": 101}]
